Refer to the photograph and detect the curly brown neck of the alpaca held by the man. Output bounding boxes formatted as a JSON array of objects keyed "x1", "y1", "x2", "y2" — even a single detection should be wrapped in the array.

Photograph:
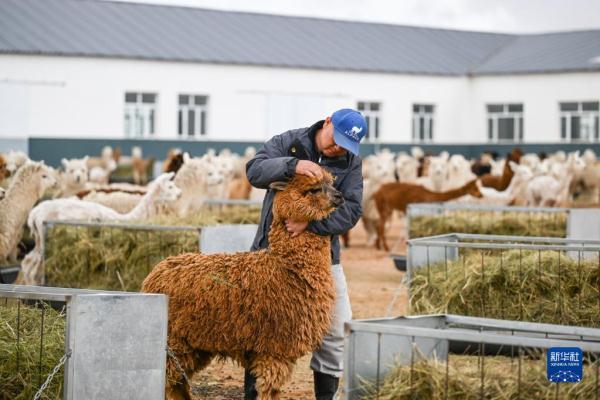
[{"x1": 269, "y1": 217, "x2": 331, "y2": 268}]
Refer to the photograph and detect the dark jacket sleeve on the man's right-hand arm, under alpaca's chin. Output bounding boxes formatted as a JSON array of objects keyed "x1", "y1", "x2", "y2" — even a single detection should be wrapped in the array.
[{"x1": 308, "y1": 159, "x2": 363, "y2": 236}]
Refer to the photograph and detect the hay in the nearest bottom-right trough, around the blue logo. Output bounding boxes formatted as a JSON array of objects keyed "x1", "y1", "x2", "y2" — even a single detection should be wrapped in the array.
[{"x1": 364, "y1": 352, "x2": 598, "y2": 400}]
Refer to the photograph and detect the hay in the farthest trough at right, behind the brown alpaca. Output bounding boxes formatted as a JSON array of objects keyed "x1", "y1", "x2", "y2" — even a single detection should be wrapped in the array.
[{"x1": 409, "y1": 210, "x2": 567, "y2": 238}]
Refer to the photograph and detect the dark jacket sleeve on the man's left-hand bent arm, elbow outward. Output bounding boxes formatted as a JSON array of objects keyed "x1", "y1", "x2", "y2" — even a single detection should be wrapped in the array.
[{"x1": 246, "y1": 135, "x2": 298, "y2": 189}]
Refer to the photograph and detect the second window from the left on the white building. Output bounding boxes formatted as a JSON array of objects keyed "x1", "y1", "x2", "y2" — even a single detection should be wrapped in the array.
[{"x1": 177, "y1": 94, "x2": 208, "y2": 139}]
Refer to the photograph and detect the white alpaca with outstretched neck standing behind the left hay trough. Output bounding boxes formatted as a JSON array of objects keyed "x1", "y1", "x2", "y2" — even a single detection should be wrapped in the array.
[{"x1": 21, "y1": 172, "x2": 181, "y2": 285}]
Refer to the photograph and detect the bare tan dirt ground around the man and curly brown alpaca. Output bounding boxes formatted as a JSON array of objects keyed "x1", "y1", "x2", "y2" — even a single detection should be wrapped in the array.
[{"x1": 193, "y1": 220, "x2": 406, "y2": 400}]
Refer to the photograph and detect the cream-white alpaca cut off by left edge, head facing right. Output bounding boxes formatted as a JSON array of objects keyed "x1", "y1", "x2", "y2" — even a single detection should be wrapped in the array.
[{"x1": 0, "y1": 161, "x2": 56, "y2": 264}]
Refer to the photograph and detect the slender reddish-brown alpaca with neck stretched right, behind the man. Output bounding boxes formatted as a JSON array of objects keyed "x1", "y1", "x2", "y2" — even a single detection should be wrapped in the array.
[{"x1": 373, "y1": 180, "x2": 483, "y2": 251}]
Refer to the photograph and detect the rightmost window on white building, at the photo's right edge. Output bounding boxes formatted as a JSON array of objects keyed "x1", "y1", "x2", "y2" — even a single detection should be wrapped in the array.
[{"x1": 560, "y1": 101, "x2": 600, "y2": 142}]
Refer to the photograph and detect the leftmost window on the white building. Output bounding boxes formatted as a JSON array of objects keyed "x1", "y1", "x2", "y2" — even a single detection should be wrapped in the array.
[{"x1": 124, "y1": 92, "x2": 156, "y2": 138}]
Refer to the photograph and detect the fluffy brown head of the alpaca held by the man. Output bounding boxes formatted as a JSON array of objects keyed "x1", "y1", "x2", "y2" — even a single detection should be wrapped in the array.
[{"x1": 270, "y1": 169, "x2": 344, "y2": 221}]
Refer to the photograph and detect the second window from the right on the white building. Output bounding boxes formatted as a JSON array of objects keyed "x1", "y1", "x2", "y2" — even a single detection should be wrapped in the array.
[{"x1": 487, "y1": 104, "x2": 523, "y2": 142}]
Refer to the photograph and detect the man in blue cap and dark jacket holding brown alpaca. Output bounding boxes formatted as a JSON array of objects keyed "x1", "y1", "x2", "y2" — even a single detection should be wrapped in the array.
[{"x1": 244, "y1": 109, "x2": 367, "y2": 400}]
